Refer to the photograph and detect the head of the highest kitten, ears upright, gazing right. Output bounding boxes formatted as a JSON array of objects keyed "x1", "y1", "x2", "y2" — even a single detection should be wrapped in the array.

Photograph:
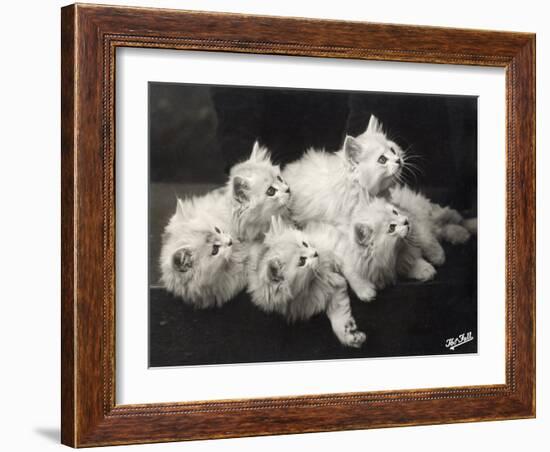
[{"x1": 344, "y1": 116, "x2": 404, "y2": 196}]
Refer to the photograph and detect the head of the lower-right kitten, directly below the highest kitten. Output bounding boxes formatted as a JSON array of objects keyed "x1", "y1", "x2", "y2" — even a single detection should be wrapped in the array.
[{"x1": 352, "y1": 199, "x2": 411, "y2": 253}]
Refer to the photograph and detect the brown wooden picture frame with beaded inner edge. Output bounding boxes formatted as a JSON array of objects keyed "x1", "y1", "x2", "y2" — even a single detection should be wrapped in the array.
[{"x1": 61, "y1": 4, "x2": 535, "y2": 447}]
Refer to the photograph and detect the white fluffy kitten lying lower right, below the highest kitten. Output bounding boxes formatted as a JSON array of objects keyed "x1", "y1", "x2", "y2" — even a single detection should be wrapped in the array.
[{"x1": 305, "y1": 198, "x2": 436, "y2": 301}]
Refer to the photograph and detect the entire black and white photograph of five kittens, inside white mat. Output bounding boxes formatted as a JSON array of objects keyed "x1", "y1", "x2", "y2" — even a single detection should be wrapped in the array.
[{"x1": 148, "y1": 81, "x2": 479, "y2": 367}]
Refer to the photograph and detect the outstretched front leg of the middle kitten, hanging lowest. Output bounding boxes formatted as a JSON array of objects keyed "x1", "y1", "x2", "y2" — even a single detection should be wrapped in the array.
[{"x1": 327, "y1": 284, "x2": 367, "y2": 348}]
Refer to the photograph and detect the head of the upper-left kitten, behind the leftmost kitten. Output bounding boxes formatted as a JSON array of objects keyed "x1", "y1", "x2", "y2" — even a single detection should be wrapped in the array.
[{"x1": 231, "y1": 144, "x2": 290, "y2": 214}]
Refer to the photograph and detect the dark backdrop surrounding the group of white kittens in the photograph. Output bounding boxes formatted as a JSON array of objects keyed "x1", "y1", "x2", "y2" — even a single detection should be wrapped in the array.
[{"x1": 149, "y1": 83, "x2": 477, "y2": 366}]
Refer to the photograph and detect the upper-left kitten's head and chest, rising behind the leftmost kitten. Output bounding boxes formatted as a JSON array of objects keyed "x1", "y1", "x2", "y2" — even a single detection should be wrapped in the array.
[{"x1": 226, "y1": 142, "x2": 290, "y2": 241}]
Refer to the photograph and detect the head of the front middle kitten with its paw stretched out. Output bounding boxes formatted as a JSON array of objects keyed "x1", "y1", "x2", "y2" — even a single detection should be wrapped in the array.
[{"x1": 265, "y1": 222, "x2": 319, "y2": 290}]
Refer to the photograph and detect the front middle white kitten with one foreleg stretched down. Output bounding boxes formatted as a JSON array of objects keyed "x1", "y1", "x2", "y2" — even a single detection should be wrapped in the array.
[{"x1": 248, "y1": 218, "x2": 366, "y2": 347}]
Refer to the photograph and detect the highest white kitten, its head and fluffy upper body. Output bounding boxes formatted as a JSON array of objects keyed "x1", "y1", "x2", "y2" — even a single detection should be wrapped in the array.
[{"x1": 283, "y1": 116, "x2": 405, "y2": 225}]
